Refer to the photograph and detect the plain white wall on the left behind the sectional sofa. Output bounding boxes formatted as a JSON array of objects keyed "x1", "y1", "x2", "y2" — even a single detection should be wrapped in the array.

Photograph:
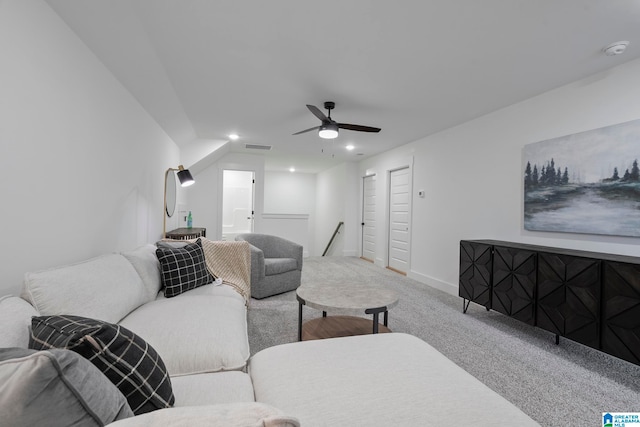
[{"x1": 0, "y1": 0, "x2": 179, "y2": 295}]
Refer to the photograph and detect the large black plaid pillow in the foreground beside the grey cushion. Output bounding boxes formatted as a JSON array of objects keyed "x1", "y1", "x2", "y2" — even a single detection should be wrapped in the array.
[{"x1": 29, "y1": 316, "x2": 175, "y2": 415}]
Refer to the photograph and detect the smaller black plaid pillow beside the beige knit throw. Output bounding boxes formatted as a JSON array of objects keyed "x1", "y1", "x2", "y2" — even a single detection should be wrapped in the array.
[{"x1": 156, "y1": 239, "x2": 214, "y2": 298}]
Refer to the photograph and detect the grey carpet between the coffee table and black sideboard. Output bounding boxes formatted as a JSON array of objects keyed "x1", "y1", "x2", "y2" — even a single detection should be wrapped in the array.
[{"x1": 249, "y1": 257, "x2": 640, "y2": 427}]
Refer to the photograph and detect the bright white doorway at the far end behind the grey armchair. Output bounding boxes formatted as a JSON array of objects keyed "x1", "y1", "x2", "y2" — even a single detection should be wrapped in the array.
[{"x1": 222, "y1": 170, "x2": 254, "y2": 240}]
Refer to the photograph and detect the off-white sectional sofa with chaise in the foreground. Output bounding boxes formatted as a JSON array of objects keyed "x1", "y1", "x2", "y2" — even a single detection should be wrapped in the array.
[{"x1": 0, "y1": 242, "x2": 538, "y2": 427}]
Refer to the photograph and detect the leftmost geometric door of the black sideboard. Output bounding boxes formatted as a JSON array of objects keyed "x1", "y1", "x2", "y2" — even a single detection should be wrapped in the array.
[{"x1": 458, "y1": 240, "x2": 492, "y2": 309}]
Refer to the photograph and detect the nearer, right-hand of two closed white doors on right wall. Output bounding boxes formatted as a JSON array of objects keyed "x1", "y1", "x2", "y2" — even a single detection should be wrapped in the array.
[{"x1": 388, "y1": 168, "x2": 410, "y2": 273}]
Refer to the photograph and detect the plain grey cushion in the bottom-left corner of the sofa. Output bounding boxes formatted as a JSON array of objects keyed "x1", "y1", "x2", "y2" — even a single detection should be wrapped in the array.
[{"x1": 0, "y1": 348, "x2": 133, "y2": 427}]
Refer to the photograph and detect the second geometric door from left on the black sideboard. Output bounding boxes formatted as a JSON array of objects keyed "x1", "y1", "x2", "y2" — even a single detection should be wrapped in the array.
[{"x1": 491, "y1": 246, "x2": 536, "y2": 325}]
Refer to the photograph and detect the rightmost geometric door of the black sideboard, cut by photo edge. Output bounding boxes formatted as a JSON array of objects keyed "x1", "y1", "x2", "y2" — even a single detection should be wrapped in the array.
[{"x1": 602, "y1": 261, "x2": 640, "y2": 365}]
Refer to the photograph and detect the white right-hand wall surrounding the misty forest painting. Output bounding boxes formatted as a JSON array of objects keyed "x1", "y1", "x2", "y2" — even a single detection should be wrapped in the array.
[{"x1": 359, "y1": 60, "x2": 640, "y2": 294}]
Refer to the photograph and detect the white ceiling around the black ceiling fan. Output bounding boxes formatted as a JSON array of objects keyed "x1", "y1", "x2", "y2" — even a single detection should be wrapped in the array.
[{"x1": 47, "y1": 0, "x2": 640, "y2": 172}]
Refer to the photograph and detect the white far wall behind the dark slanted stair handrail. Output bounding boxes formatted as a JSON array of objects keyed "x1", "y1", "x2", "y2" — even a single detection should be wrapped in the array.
[{"x1": 313, "y1": 163, "x2": 361, "y2": 256}]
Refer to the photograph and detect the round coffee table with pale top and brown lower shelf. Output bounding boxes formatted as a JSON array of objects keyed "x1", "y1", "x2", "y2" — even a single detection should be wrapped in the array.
[{"x1": 296, "y1": 283, "x2": 398, "y2": 341}]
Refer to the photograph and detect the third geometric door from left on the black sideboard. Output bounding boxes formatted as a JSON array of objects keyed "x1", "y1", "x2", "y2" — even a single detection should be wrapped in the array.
[{"x1": 537, "y1": 252, "x2": 601, "y2": 348}]
